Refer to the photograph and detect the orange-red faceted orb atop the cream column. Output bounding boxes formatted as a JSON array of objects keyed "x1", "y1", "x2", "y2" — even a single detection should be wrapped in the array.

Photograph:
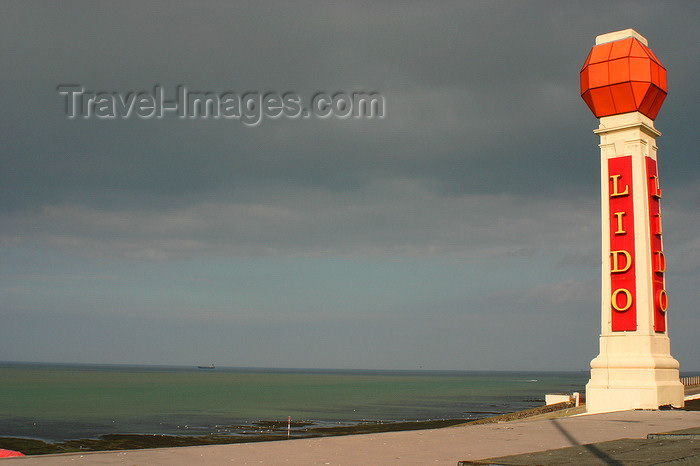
[{"x1": 581, "y1": 37, "x2": 668, "y2": 120}]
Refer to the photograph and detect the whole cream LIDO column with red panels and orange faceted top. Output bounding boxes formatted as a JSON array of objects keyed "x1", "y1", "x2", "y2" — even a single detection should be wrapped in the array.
[{"x1": 581, "y1": 29, "x2": 683, "y2": 413}]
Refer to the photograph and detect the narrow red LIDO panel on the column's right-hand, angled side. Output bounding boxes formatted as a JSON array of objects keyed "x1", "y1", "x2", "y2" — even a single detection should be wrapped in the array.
[{"x1": 645, "y1": 157, "x2": 668, "y2": 332}]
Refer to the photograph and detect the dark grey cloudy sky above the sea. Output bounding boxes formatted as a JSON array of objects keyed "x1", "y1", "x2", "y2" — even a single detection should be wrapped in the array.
[{"x1": 0, "y1": 1, "x2": 700, "y2": 371}]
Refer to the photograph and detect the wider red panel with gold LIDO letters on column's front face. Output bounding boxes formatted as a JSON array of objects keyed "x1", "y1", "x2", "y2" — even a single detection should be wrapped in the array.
[{"x1": 608, "y1": 155, "x2": 637, "y2": 332}]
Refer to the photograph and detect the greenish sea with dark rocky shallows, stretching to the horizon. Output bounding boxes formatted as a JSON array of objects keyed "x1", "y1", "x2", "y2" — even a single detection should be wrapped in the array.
[{"x1": 0, "y1": 363, "x2": 589, "y2": 443}]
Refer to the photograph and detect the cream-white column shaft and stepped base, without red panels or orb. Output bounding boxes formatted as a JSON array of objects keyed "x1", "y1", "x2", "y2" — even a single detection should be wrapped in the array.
[{"x1": 586, "y1": 112, "x2": 683, "y2": 413}]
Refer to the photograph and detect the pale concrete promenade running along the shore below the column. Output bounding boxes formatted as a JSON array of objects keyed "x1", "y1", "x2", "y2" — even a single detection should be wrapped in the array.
[{"x1": 5, "y1": 410, "x2": 700, "y2": 466}]
